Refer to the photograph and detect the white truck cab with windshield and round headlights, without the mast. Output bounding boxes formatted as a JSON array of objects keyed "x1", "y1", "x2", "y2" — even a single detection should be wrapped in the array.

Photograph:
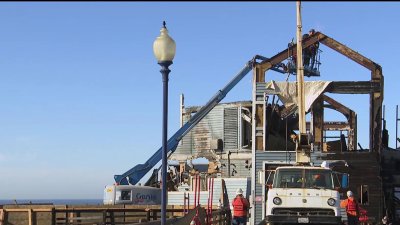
[{"x1": 265, "y1": 166, "x2": 348, "y2": 225}]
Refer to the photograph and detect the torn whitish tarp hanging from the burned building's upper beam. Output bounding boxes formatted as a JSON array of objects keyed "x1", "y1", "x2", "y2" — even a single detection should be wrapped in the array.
[{"x1": 265, "y1": 81, "x2": 331, "y2": 113}]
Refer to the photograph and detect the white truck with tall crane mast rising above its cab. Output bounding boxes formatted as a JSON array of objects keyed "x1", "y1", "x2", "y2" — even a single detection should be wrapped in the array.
[{"x1": 264, "y1": 1, "x2": 348, "y2": 225}]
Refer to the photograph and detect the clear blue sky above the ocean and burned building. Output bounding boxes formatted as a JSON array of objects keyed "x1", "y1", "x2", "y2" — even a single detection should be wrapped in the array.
[{"x1": 0, "y1": 2, "x2": 400, "y2": 199}]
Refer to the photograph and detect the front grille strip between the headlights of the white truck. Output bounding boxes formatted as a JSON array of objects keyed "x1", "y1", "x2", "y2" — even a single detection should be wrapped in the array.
[{"x1": 272, "y1": 208, "x2": 335, "y2": 216}]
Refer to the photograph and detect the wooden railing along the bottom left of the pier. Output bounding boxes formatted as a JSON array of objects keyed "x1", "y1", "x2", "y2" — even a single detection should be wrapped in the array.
[{"x1": 0, "y1": 206, "x2": 231, "y2": 225}]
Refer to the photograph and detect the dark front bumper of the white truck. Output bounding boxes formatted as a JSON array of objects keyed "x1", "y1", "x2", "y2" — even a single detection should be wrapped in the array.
[{"x1": 263, "y1": 215, "x2": 342, "y2": 225}]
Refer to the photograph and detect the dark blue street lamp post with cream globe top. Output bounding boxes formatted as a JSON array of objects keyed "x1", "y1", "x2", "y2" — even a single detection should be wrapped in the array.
[{"x1": 153, "y1": 21, "x2": 176, "y2": 225}]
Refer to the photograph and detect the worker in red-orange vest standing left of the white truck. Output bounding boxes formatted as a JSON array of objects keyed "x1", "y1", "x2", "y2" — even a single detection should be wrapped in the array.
[{"x1": 232, "y1": 188, "x2": 250, "y2": 225}]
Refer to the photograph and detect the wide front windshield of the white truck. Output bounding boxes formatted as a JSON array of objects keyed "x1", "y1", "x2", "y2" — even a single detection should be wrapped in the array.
[{"x1": 272, "y1": 168, "x2": 333, "y2": 189}]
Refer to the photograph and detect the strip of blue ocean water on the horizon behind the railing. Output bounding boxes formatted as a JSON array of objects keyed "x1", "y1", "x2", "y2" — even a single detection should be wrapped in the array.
[{"x1": 0, "y1": 199, "x2": 103, "y2": 205}]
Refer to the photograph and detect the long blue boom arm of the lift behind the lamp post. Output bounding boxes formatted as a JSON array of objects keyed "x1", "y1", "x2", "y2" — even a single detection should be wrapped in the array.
[{"x1": 114, "y1": 58, "x2": 256, "y2": 185}]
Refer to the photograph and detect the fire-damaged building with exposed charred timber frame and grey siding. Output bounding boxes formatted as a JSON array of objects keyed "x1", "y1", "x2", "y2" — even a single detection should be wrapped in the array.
[{"x1": 169, "y1": 32, "x2": 400, "y2": 224}]
